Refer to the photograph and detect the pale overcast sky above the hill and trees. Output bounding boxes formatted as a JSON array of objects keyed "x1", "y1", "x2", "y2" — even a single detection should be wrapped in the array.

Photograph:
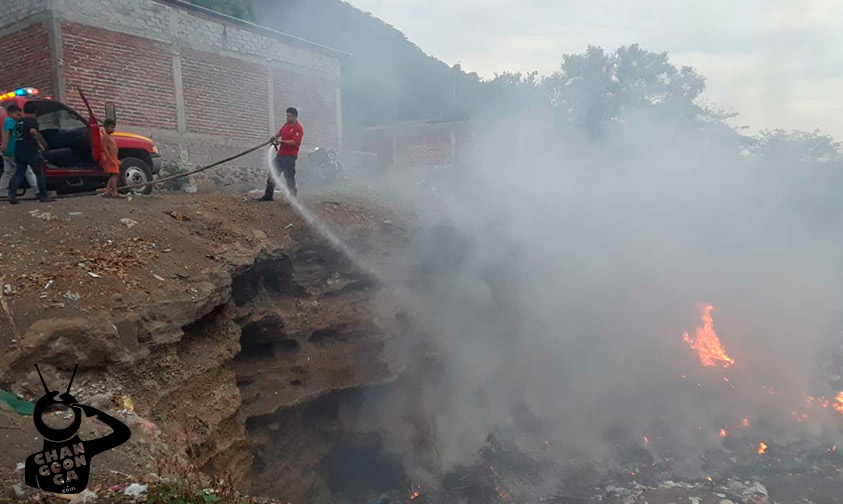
[{"x1": 350, "y1": 0, "x2": 843, "y2": 140}]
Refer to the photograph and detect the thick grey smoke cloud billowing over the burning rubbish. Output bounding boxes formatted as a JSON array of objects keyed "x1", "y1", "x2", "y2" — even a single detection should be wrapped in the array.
[{"x1": 346, "y1": 101, "x2": 843, "y2": 477}]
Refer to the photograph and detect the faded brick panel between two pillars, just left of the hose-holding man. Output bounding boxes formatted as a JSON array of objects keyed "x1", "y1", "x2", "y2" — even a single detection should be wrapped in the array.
[{"x1": 182, "y1": 51, "x2": 269, "y2": 139}]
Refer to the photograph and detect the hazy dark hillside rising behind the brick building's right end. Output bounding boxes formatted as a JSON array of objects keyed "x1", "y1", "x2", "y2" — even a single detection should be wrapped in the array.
[{"x1": 255, "y1": 0, "x2": 479, "y2": 128}]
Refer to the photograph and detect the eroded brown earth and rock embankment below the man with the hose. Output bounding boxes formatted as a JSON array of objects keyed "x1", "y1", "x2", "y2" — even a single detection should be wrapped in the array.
[{"x1": 0, "y1": 194, "x2": 418, "y2": 502}]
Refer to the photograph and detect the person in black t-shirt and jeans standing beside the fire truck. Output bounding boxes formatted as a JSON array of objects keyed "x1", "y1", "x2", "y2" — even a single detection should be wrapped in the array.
[{"x1": 9, "y1": 101, "x2": 55, "y2": 205}]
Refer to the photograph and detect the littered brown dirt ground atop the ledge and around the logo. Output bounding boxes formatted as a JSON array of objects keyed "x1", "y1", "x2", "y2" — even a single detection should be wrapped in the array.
[{"x1": 0, "y1": 193, "x2": 408, "y2": 502}]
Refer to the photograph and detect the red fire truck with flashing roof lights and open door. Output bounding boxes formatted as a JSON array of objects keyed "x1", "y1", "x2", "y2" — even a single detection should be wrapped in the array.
[{"x1": 0, "y1": 87, "x2": 161, "y2": 194}]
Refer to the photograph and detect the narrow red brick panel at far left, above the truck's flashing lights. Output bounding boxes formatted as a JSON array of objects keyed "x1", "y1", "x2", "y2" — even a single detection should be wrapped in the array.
[{"x1": 0, "y1": 22, "x2": 53, "y2": 96}]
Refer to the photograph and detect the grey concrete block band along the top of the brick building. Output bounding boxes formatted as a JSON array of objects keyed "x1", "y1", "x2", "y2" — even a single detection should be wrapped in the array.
[{"x1": 50, "y1": 0, "x2": 344, "y2": 79}]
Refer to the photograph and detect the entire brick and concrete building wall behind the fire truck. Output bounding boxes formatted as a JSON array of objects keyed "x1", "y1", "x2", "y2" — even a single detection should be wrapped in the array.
[{"x1": 0, "y1": 0, "x2": 345, "y2": 189}]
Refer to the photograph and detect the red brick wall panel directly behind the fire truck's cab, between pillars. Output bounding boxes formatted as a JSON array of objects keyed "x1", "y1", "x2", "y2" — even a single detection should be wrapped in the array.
[{"x1": 61, "y1": 21, "x2": 177, "y2": 129}]
